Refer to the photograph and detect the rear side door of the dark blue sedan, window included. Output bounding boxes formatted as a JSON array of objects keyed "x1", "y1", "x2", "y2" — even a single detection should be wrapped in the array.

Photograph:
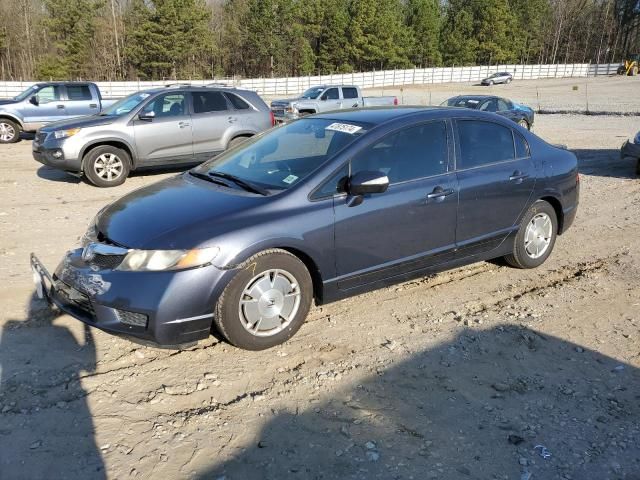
[{"x1": 455, "y1": 119, "x2": 536, "y2": 256}]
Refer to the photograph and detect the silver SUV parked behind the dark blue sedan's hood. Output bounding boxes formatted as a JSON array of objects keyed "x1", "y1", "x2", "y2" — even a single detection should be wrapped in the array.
[{"x1": 33, "y1": 85, "x2": 274, "y2": 187}]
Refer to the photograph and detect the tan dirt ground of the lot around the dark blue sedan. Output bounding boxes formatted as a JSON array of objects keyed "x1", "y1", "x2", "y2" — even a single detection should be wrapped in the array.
[{"x1": 0, "y1": 79, "x2": 640, "y2": 480}]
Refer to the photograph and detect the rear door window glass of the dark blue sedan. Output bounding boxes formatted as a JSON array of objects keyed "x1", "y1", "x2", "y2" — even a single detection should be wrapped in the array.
[{"x1": 457, "y1": 120, "x2": 515, "y2": 168}]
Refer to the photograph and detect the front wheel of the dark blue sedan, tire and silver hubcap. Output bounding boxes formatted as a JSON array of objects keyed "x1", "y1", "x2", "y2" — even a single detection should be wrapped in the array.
[{"x1": 214, "y1": 249, "x2": 313, "y2": 350}]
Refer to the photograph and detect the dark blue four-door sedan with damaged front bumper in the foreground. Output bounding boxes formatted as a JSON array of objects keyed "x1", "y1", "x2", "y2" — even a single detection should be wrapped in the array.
[{"x1": 32, "y1": 108, "x2": 579, "y2": 350}]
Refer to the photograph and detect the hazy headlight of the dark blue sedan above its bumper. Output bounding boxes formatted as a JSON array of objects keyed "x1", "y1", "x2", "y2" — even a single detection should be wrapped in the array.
[{"x1": 116, "y1": 247, "x2": 220, "y2": 272}]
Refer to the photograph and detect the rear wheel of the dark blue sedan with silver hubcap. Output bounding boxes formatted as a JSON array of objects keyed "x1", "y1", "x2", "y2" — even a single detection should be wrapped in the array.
[{"x1": 504, "y1": 200, "x2": 558, "y2": 268}]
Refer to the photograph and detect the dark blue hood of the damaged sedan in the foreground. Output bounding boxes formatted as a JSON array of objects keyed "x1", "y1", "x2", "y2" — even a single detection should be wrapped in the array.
[{"x1": 96, "y1": 172, "x2": 269, "y2": 250}]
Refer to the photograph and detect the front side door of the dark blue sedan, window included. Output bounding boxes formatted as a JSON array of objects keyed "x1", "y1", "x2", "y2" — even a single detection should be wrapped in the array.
[{"x1": 334, "y1": 121, "x2": 457, "y2": 290}]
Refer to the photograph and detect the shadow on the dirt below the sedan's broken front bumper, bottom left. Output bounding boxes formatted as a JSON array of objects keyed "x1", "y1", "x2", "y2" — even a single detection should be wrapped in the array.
[{"x1": 0, "y1": 297, "x2": 105, "y2": 480}]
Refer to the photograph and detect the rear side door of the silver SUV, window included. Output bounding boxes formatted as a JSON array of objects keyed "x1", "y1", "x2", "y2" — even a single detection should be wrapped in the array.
[{"x1": 191, "y1": 90, "x2": 234, "y2": 162}]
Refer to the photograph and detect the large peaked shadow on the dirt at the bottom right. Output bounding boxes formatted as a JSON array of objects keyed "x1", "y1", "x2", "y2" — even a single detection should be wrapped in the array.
[{"x1": 198, "y1": 325, "x2": 640, "y2": 480}]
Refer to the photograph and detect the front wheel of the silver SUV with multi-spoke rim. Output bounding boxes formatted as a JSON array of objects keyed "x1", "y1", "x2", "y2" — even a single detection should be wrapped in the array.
[{"x1": 82, "y1": 145, "x2": 131, "y2": 188}]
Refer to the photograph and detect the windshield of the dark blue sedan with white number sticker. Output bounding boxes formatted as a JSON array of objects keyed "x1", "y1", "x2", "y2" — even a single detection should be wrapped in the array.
[{"x1": 192, "y1": 118, "x2": 370, "y2": 190}]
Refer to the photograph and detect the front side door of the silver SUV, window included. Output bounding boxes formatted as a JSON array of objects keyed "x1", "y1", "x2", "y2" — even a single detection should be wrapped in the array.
[{"x1": 133, "y1": 92, "x2": 194, "y2": 166}]
